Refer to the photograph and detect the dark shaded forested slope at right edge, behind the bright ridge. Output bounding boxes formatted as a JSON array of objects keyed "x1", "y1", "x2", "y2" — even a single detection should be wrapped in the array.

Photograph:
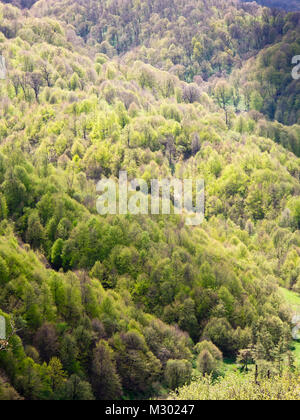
[{"x1": 233, "y1": 13, "x2": 300, "y2": 125}]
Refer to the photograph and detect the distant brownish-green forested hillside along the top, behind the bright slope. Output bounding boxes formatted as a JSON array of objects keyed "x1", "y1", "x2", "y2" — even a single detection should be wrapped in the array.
[{"x1": 32, "y1": 0, "x2": 278, "y2": 81}]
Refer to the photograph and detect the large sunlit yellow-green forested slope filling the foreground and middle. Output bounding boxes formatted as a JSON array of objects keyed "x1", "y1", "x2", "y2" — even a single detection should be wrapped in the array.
[{"x1": 0, "y1": 3, "x2": 300, "y2": 399}]
